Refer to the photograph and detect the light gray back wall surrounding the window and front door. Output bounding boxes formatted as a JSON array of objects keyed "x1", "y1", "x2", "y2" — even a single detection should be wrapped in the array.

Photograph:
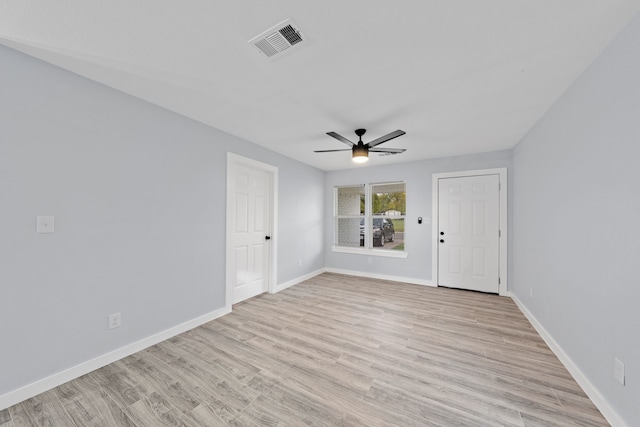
[{"x1": 324, "y1": 150, "x2": 511, "y2": 281}]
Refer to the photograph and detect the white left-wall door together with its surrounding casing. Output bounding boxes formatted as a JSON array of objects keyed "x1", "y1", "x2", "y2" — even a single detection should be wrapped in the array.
[{"x1": 226, "y1": 153, "x2": 277, "y2": 307}]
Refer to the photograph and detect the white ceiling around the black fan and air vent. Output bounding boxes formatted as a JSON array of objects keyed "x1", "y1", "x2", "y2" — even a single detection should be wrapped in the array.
[{"x1": 0, "y1": 0, "x2": 640, "y2": 170}]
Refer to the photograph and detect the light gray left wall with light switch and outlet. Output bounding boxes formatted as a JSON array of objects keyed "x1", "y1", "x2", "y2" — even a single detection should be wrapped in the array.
[{"x1": 0, "y1": 46, "x2": 324, "y2": 395}]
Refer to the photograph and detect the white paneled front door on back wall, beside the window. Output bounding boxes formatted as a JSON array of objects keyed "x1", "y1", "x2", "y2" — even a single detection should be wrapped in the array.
[{"x1": 436, "y1": 175, "x2": 500, "y2": 293}]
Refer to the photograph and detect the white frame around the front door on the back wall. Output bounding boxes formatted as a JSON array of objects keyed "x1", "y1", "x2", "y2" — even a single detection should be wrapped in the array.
[{"x1": 431, "y1": 168, "x2": 509, "y2": 296}]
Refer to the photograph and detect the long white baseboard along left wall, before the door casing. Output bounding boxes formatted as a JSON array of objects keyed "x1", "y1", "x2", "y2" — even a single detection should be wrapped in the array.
[{"x1": 0, "y1": 307, "x2": 231, "y2": 411}]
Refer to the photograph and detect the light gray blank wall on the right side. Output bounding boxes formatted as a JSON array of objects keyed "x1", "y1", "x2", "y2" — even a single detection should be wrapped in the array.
[{"x1": 512, "y1": 17, "x2": 640, "y2": 426}]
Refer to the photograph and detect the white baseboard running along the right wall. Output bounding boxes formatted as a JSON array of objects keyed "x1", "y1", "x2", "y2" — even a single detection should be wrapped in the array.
[{"x1": 509, "y1": 292, "x2": 628, "y2": 427}]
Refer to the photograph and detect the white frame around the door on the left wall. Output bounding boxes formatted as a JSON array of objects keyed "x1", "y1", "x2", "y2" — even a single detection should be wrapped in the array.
[{"x1": 225, "y1": 152, "x2": 278, "y2": 311}]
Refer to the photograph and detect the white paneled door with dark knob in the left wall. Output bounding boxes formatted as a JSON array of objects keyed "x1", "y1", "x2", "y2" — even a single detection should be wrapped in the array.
[{"x1": 229, "y1": 164, "x2": 271, "y2": 304}]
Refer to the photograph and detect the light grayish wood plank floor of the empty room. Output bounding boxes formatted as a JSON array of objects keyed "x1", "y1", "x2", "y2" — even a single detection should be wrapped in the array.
[{"x1": 0, "y1": 273, "x2": 608, "y2": 427}]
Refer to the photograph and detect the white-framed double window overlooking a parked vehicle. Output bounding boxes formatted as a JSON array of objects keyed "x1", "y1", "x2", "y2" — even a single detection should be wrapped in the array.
[{"x1": 335, "y1": 182, "x2": 406, "y2": 253}]
